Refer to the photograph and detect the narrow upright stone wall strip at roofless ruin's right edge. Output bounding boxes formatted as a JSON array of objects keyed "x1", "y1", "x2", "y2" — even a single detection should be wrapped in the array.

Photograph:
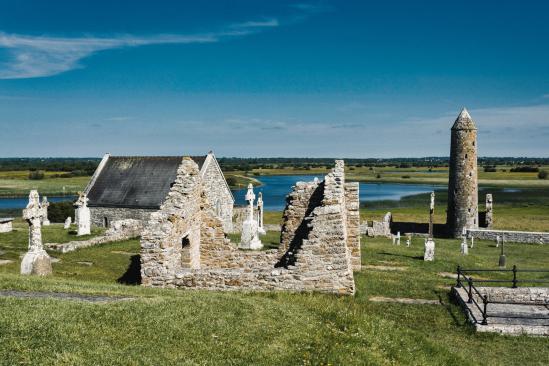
[{"x1": 345, "y1": 183, "x2": 361, "y2": 271}]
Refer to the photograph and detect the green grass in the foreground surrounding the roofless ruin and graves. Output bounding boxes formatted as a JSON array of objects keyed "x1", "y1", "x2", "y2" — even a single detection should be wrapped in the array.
[{"x1": 0, "y1": 223, "x2": 549, "y2": 365}]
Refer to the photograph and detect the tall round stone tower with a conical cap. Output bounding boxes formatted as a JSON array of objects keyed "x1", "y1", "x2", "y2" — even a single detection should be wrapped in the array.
[{"x1": 446, "y1": 108, "x2": 478, "y2": 238}]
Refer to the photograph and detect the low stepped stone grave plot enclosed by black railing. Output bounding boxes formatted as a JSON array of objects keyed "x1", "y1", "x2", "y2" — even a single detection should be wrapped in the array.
[{"x1": 452, "y1": 287, "x2": 549, "y2": 336}]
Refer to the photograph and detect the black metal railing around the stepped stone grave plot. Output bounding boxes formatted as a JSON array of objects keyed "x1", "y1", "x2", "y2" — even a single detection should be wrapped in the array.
[{"x1": 456, "y1": 266, "x2": 549, "y2": 325}]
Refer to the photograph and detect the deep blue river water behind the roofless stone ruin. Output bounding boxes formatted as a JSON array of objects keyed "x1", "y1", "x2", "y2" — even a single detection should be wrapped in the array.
[{"x1": 233, "y1": 175, "x2": 445, "y2": 211}]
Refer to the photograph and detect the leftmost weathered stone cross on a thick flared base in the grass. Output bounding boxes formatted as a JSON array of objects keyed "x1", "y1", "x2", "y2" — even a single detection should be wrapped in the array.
[{"x1": 21, "y1": 190, "x2": 52, "y2": 276}]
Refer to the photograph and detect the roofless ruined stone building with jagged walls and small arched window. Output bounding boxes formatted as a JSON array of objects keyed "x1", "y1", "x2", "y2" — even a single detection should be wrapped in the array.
[{"x1": 141, "y1": 159, "x2": 360, "y2": 295}]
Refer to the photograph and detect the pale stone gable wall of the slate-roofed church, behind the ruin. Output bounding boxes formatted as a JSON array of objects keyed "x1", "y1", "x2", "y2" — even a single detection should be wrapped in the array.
[{"x1": 202, "y1": 155, "x2": 234, "y2": 232}]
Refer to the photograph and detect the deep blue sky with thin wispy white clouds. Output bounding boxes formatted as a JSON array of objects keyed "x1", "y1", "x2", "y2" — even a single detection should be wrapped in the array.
[{"x1": 0, "y1": 0, "x2": 549, "y2": 158}]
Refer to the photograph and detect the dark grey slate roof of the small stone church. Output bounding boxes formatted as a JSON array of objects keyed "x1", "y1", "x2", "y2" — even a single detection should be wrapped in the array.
[{"x1": 88, "y1": 156, "x2": 206, "y2": 209}]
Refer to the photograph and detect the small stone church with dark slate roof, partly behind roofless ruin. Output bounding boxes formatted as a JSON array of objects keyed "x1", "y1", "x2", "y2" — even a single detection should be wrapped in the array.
[{"x1": 85, "y1": 152, "x2": 234, "y2": 232}]
